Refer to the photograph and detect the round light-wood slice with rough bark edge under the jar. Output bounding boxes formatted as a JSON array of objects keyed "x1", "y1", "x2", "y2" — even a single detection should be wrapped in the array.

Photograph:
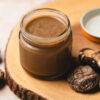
[{"x1": 5, "y1": 0, "x2": 100, "y2": 100}]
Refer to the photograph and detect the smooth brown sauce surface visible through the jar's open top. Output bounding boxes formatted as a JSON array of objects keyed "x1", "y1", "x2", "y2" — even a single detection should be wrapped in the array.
[{"x1": 25, "y1": 16, "x2": 66, "y2": 38}]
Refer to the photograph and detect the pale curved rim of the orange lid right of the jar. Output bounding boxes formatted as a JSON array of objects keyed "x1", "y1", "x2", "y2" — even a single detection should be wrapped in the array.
[{"x1": 80, "y1": 8, "x2": 100, "y2": 39}]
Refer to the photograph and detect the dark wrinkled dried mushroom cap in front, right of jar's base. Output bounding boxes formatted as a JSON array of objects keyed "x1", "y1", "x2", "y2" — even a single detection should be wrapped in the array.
[{"x1": 68, "y1": 65, "x2": 99, "y2": 92}]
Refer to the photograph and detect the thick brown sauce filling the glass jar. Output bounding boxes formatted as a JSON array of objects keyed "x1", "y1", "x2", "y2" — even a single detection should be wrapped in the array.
[{"x1": 19, "y1": 16, "x2": 72, "y2": 77}]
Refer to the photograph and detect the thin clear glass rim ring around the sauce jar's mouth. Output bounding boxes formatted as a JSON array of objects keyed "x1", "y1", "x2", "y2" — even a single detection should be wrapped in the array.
[{"x1": 20, "y1": 8, "x2": 71, "y2": 46}]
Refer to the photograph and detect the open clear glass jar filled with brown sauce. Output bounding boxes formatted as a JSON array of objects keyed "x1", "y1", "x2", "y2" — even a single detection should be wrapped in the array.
[{"x1": 19, "y1": 8, "x2": 72, "y2": 78}]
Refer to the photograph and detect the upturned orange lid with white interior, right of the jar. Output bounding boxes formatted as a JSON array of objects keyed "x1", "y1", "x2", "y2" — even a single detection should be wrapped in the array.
[{"x1": 80, "y1": 8, "x2": 100, "y2": 43}]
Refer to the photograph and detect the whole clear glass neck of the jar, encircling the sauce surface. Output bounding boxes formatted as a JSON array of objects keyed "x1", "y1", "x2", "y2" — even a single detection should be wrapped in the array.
[{"x1": 20, "y1": 8, "x2": 71, "y2": 47}]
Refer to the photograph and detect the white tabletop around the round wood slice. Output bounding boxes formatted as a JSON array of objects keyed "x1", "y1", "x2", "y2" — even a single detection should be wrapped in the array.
[{"x1": 0, "y1": 0, "x2": 51, "y2": 100}]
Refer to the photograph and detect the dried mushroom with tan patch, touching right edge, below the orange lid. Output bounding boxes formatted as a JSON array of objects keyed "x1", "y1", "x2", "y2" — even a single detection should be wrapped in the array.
[{"x1": 79, "y1": 48, "x2": 100, "y2": 69}]
